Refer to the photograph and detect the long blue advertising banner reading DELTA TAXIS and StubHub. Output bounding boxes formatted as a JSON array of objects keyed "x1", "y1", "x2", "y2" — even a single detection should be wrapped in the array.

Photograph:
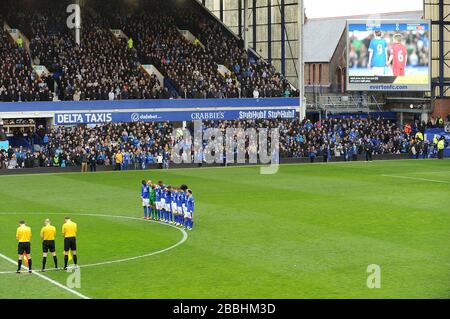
[{"x1": 54, "y1": 108, "x2": 296, "y2": 125}]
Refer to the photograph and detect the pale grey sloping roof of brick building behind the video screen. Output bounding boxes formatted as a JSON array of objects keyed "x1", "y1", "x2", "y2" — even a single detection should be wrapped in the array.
[{"x1": 303, "y1": 11, "x2": 423, "y2": 63}]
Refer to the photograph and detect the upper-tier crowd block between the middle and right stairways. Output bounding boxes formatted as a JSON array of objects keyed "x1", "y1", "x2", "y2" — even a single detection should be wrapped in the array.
[{"x1": 117, "y1": 1, "x2": 243, "y2": 98}]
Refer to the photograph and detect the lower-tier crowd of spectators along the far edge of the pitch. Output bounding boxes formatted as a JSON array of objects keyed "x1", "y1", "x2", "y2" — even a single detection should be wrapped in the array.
[{"x1": 0, "y1": 117, "x2": 448, "y2": 169}]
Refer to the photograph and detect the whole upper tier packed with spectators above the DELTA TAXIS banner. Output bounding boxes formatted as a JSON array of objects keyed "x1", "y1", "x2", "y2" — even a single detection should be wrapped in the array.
[{"x1": 1, "y1": 0, "x2": 295, "y2": 101}]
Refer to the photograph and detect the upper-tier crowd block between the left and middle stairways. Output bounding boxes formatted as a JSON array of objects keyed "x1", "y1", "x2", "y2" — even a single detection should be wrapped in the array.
[{"x1": 19, "y1": 5, "x2": 164, "y2": 101}]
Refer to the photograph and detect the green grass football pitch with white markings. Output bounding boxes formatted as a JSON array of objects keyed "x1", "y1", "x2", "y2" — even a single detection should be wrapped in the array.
[{"x1": 0, "y1": 160, "x2": 450, "y2": 299}]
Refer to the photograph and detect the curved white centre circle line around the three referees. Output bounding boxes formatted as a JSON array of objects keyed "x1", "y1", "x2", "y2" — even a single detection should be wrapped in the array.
[{"x1": 0, "y1": 212, "x2": 188, "y2": 272}]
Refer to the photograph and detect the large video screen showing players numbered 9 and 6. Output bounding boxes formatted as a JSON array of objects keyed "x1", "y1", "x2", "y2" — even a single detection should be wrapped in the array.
[{"x1": 347, "y1": 20, "x2": 431, "y2": 91}]
